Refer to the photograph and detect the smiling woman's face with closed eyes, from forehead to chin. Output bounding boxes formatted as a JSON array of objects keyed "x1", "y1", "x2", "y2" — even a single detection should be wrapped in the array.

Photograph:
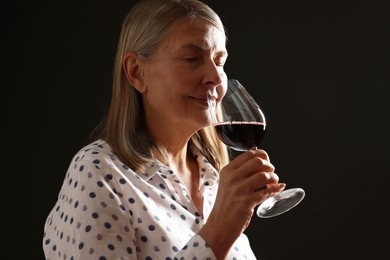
[{"x1": 141, "y1": 20, "x2": 227, "y2": 134}]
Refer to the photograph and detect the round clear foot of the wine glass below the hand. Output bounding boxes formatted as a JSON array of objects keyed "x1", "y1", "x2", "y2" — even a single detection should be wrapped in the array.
[{"x1": 256, "y1": 188, "x2": 305, "y2": 218}]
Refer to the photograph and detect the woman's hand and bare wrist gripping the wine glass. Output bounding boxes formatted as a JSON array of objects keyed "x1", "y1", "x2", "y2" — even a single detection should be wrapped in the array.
[{"x1": 200, "y1": 149, "x2": 286, "y2": 256}]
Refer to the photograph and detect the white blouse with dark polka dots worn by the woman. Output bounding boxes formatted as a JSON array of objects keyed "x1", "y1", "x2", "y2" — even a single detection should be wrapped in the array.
[{"x1": 43, "y1": 140, "x2": 256, "y2": 260}]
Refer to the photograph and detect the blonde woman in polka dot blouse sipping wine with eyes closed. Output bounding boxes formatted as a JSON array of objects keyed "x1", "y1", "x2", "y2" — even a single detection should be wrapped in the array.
[{"x1": 43, "y1": 0, "x2": 285, "y2": 259}]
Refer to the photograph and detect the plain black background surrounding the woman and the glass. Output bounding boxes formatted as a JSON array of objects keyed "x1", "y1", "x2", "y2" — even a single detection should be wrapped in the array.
[{"x1": 0, "y1": 0, "x2": 390, "y2": 260}]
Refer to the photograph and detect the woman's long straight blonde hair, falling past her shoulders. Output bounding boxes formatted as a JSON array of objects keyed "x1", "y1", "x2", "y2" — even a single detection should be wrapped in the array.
[{"x1": 92, "y1": 0, "x2": 229, "y2": 171}]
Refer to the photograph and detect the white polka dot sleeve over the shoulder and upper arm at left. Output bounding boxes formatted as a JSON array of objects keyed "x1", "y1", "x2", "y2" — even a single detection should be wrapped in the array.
[{"x1": 44, "y1": 156, "x2": 137, "y2": 260}]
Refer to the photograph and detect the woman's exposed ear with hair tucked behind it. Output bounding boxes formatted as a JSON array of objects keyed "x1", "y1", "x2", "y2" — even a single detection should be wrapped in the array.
[{"x1": 122, "y1": 51, "x2": 146, "y2": 93}]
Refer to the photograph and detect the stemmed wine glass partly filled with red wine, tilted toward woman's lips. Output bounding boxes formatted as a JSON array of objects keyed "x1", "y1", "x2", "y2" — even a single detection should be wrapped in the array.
[{"x1": 208, "y1": 79, "x2": 305, "y2": 218}]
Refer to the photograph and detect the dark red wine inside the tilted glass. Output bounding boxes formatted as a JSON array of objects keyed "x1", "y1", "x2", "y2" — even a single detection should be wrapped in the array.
[{"x1": 215, "y1": 121, "x2": 265, "y2": 151}]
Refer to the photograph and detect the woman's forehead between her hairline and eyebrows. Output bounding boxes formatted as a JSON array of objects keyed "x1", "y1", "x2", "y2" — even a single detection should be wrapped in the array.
[{"x1": 161, "y1": 19, "x2": 226, "y2": 52}]
